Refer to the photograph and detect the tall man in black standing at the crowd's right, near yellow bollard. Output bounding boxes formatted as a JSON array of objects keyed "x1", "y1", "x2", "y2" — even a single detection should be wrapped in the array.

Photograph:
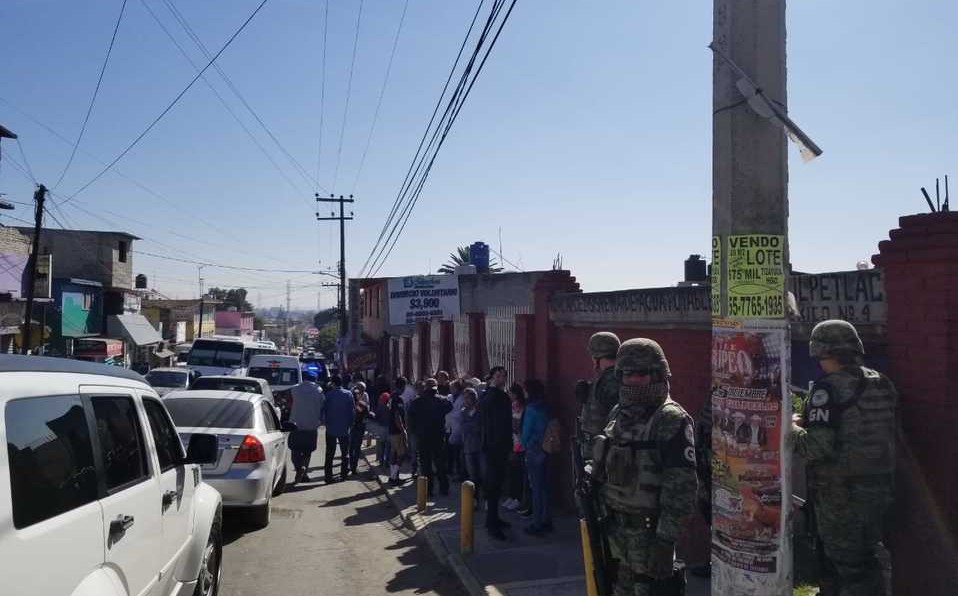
[{"x1": 479, "y1": 366, "x2": 512, "y2": 540}]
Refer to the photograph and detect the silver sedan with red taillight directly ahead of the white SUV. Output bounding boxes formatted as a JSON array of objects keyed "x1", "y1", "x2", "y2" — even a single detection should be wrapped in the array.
[{"x1": 163, "y1": 391, "x2": 296, "y2": 527}]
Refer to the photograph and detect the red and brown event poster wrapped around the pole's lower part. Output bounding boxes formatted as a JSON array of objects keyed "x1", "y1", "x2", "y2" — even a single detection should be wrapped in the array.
[{"x1": 712, "y1": 321, "x2": 791, "y2": 595}]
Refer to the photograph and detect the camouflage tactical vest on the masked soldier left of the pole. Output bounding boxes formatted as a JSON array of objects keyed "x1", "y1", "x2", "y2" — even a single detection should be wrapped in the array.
[{"x1": 596, "y1": 398, "x2": 681, "y2": 513}]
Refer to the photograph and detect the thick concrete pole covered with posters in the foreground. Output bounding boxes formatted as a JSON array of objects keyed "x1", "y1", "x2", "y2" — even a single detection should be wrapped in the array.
[{"x1": 709, "y1": 0, "x2": 792, "y2": 596}]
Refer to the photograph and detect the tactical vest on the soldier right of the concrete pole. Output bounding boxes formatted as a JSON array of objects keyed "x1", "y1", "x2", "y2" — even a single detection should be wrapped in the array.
[{"x1": 816, "y1": 367, "x2": 896, "y2": 477}]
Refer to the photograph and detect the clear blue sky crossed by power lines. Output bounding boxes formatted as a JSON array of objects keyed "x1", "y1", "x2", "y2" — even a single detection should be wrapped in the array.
[{"x1": 0, "y1": 0, "x2": 958, "y2": 307}]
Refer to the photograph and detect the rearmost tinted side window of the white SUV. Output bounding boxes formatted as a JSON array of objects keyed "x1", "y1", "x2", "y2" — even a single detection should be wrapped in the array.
[{"x1": 5, "y1": 395, "x2": 97, "y2": 528}]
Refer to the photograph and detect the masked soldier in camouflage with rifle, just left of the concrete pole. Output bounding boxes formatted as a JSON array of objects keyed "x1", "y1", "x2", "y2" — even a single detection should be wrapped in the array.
[{"x1": 594, "y1": 338, "x2": 697, "y2": 596}]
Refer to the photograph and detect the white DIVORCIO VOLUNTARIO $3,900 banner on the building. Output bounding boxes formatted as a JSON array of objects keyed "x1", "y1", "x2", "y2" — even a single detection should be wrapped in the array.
[{"x1": 389, "y1": 275, "x2": 459, "y2": 325}]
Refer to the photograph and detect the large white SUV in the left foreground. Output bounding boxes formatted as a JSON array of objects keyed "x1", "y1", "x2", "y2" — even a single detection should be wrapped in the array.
[{"x1": 0, "y1": 355, "x2": 222, "y2": 596}]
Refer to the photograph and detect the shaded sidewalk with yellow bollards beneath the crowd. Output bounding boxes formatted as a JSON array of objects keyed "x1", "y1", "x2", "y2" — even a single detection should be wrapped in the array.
[{"x1": 366, "y1": 450, "x2": 708, "y2": 596}]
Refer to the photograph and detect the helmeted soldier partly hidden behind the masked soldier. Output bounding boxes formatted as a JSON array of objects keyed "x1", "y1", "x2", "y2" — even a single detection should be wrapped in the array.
[{"x1": 577, "y1": 331, "x2": 621, "y2": 460}]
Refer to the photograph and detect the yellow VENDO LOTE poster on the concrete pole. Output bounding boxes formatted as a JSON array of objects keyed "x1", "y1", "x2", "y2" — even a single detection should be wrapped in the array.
[{"x1": 725, "y1": 234, "x2": 785, "y2": 319}]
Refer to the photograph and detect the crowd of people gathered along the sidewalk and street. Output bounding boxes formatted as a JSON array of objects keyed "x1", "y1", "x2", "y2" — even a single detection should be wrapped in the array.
[{"x1": 289, "y1": 366, "x2": 553, "y2": 540}]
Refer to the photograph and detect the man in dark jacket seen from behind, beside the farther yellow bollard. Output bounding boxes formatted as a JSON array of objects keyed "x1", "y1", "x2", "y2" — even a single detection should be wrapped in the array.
[{"x1": 409, "y1": 379, "x2": 452, "y2": 496}]
